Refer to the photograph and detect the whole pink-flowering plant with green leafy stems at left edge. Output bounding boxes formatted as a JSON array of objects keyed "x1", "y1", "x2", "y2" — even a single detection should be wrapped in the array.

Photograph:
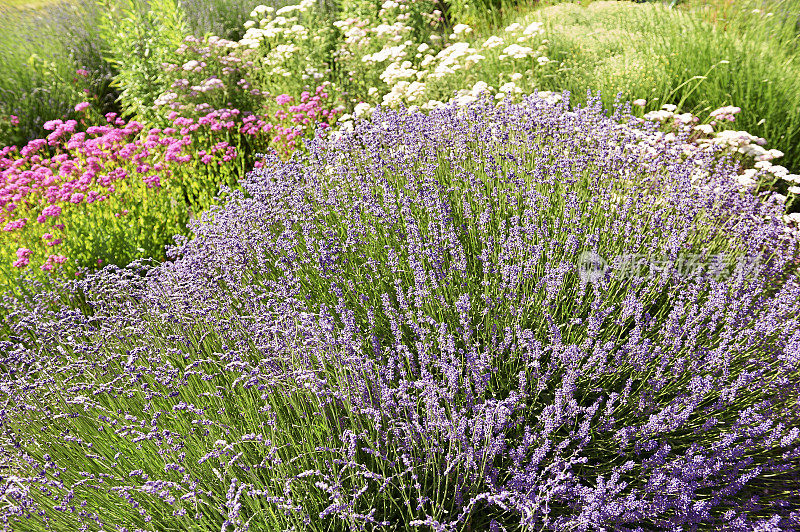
[{"x1": 0, "y1": 111, "x2": 250, "y2": 288}]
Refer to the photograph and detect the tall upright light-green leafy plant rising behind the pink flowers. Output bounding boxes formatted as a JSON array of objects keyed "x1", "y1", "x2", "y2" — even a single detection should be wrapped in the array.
[{"x1": 100, "y1": 0, "x2": 189, "y2": 122}]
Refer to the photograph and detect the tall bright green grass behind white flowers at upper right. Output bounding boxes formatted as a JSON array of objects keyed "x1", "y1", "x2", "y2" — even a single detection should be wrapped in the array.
[{"x1": 496, "y1": 1, "x2": 800, "y2": 169}]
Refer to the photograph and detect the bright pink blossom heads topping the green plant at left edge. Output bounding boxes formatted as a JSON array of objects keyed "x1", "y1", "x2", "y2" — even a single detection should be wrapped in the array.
[{"x1": 0, "y1": 110, "x2": 260, "y2": 271}]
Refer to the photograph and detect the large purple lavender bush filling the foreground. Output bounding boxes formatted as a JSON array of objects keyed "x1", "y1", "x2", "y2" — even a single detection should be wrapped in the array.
[{"x1": 0, "y1": 94, "x2": 800, "y2": 531}]
